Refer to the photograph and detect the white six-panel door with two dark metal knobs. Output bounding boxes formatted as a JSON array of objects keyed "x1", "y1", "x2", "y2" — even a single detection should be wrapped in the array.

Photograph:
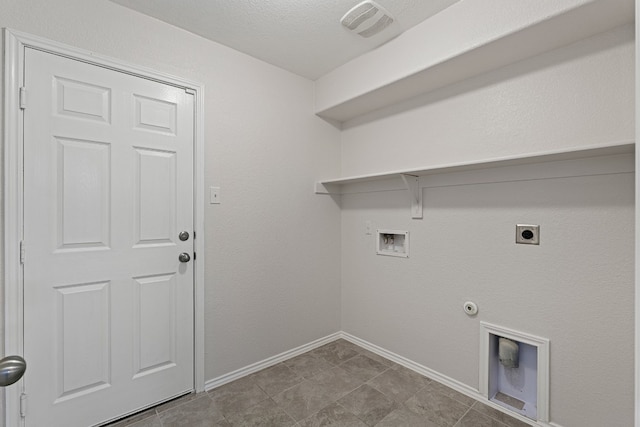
[{"x1": 24, "y1": 48, "x2": 194, "y2": 427}]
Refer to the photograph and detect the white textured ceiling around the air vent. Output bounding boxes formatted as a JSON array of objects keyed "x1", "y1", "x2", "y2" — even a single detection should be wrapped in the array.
[{"x1": 111, "y1": 0, "x2": 459, "y2": 80}]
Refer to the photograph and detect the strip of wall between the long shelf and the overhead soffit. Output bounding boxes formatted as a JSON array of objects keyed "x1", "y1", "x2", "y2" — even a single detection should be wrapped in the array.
[{"x1": 342, "y1": 26, "x2": 634, "y2": 176}]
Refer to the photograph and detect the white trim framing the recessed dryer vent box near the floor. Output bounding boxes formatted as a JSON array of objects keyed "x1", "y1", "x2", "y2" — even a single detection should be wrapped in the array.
[{"x1": 479, "y1": 322, "x2": 549, "y2": 422}]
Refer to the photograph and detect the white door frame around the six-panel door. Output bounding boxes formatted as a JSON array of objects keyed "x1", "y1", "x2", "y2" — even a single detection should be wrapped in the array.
[{"x1": 3, "y1": 28, "x2": 205, "y2": 426}]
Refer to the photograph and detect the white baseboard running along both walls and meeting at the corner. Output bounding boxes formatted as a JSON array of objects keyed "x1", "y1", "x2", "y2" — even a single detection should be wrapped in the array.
[{"x1": 205, "y1": 331, "x2": 562, "y2": 427}]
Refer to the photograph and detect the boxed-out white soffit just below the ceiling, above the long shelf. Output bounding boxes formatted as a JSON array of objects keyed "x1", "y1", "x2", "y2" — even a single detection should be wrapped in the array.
[{"x1": 315, "y1": 0, "x2": 634, "y2": 122}]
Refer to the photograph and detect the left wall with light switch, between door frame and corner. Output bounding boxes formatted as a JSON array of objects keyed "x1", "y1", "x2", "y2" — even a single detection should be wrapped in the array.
[{"x1": 0, "y1": 0, "x2": 340, "y2": 402}]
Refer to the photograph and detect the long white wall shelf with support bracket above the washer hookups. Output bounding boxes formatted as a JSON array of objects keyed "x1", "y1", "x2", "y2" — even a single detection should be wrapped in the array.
[{"x1": 315, "y1": 141, "x2": 635, "y2": 198}]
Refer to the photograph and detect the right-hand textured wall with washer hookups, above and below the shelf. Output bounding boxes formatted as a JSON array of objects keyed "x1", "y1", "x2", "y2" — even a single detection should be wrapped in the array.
[{"x1": 342, "y1": 26, "x2": 634, "y2": 427}]
